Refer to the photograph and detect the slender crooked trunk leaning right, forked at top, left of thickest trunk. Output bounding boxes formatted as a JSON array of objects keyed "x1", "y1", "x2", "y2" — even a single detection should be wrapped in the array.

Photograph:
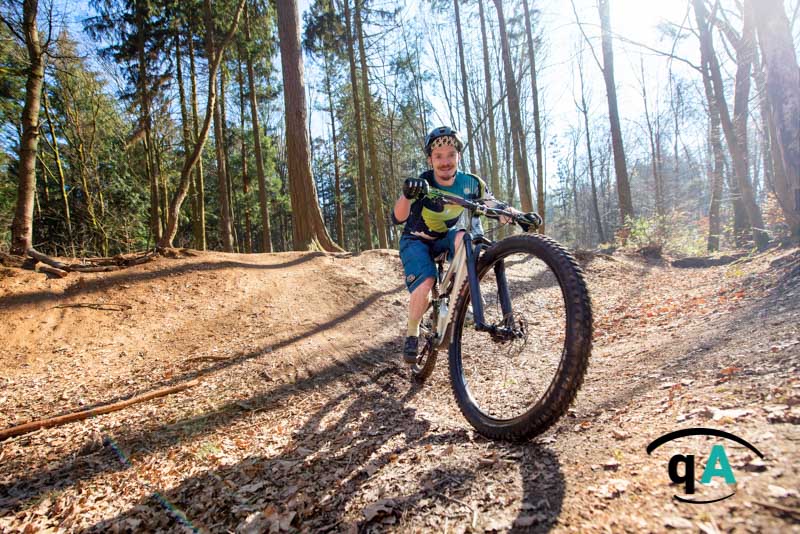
[{"x1": 159, "y1": 0, "x2": 245, "y2": 251}]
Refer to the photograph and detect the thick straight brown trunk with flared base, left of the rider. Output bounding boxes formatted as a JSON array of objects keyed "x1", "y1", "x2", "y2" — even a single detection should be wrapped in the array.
[{"x1": 277, "y1": 0, "x2": 342, "y2": 252}]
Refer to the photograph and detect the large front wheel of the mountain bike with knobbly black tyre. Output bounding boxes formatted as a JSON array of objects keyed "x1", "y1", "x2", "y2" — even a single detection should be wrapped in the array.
[{"x1": 450, "y1": 234, "x2": 592, "y2": 440}]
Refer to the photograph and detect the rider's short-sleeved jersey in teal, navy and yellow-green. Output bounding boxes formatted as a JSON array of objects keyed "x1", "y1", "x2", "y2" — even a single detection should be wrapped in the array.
[{"x1": 392, "y1": 171, "x2": 494, "y2": 239}]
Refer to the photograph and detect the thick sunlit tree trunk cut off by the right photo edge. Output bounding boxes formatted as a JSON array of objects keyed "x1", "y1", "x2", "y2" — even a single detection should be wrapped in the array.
[{"x1": 745, "y1": 0, "x2": 800, "y2": 239}]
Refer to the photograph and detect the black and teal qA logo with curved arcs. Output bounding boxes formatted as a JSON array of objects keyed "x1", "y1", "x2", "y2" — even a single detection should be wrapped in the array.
[{"x1": 647, "y1": 428, "x2": 764, "y2": 504}]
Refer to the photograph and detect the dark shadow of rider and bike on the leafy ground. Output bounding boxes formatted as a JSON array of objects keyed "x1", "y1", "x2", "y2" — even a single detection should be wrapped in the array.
[{"x1": 86, "y1": 366, "x2": 564, "y2": 532}]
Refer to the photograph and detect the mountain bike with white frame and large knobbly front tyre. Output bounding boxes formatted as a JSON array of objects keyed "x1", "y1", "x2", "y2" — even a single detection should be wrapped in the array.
[{"x1": 411, "y1": 194, "x2": 592, "y2": 440}]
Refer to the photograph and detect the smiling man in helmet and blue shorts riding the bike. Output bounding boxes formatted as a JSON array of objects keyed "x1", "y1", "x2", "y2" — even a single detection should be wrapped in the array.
[{"x1": 391, "y1": 126, "x2": 541, "y2": 364}]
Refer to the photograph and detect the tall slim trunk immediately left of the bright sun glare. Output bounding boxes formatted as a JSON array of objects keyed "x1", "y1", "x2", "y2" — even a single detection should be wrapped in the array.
[{"x1": 597, "y1": 0, "x2": 633, "y2": 226}]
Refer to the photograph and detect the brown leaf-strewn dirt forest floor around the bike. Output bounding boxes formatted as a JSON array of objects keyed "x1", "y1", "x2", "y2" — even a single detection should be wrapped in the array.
[{"x1": 0, "y1": 244, "x2": 800, "y2": 533}]
